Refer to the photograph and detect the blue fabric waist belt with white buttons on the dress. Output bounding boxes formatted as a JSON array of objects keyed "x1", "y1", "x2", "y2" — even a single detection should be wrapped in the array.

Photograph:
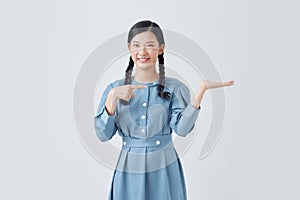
[{"x1": 122, "y1": 134, "x2": 172, "y2": 147}]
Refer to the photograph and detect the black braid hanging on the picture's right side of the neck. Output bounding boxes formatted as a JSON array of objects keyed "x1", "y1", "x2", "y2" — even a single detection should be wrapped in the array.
[{"x1": 157, "y1": 53, "x2": 170, "y2": 99}]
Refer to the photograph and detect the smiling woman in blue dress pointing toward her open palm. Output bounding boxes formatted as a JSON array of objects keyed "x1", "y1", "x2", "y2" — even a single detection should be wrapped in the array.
[{"x1": 94, "y1": 21, "x2": 233, "y2": 200}]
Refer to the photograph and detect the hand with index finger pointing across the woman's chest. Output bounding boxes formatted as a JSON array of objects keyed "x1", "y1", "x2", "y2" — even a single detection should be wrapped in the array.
[{"x1": 105, "y1": 85, "x2": 147, "y2": 115}]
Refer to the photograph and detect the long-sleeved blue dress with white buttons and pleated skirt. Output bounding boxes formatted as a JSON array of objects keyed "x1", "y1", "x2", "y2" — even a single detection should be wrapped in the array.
[{"x1": 94, "y1": 77, "x2": 201, "y2": 200}]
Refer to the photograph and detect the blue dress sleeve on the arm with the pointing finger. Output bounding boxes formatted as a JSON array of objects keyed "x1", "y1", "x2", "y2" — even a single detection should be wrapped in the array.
[{"x1": 94, "y1": 84, "x2": 117, "y2": 142}]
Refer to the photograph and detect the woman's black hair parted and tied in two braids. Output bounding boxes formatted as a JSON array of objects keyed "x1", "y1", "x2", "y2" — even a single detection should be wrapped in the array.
[{"x1": 121, "y1": 20, "x2": 170, "y2": 104}]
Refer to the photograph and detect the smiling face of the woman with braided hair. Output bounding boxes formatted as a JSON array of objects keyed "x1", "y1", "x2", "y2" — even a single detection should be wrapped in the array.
[{"x1": 128, "y1": 31, "x2": 164, "y2": 69}]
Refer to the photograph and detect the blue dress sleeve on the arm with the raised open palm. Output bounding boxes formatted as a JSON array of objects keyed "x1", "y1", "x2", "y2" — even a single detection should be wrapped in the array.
[{"x1": 170, "y1": 83, "x2": 201, "y2": 137}]
